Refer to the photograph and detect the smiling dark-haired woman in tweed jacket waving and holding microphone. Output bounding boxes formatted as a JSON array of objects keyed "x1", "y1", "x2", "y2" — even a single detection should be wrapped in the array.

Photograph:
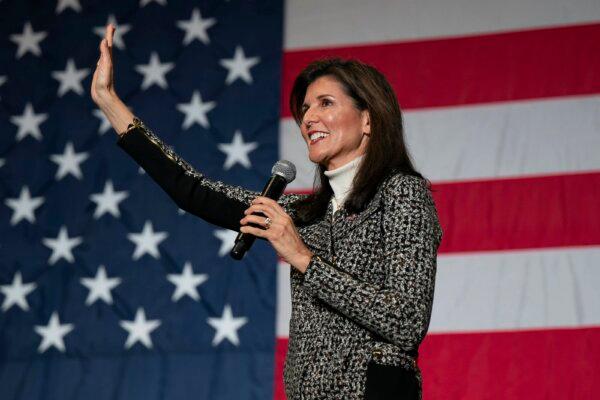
[{"x1": 91, "y1": 25, "x2": 442, "y2": 400}]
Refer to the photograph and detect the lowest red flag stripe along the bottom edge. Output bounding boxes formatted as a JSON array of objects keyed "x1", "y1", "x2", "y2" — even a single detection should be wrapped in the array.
[{"x1": 274, "y1": 327, "x2": 600, "y2": 400}]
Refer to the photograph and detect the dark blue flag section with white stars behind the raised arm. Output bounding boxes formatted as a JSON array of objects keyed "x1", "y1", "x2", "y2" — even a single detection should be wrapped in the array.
[{"x1": 0, "y1": 0, "x2": 283, "y2": 400}]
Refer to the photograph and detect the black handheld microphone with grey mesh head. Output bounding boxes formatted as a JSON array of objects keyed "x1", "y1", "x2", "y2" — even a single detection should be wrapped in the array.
[{"x1": 229, "y1": 160, "x2": 296, "y2": 260}]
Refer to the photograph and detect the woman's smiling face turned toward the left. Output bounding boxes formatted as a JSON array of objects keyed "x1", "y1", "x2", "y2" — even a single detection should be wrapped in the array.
[{"x1": 300, "y1": 76, "x2": 371, "y2": 170}]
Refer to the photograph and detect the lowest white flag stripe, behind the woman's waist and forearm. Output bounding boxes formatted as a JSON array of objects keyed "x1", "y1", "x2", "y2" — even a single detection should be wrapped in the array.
[{"x1": 277, "y1": 247, "x2": 600, "y2": 337}]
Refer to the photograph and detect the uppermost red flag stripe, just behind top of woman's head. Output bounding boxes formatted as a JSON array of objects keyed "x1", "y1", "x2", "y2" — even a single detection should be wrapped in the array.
[{"x1": 281, "y1": 24, "x2": 600, "y2": 117}]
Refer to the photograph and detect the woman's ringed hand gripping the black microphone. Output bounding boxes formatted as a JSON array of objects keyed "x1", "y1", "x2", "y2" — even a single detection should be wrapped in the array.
[{"x1": 240, "y1": 196, "x2": 313, "y2": 273}]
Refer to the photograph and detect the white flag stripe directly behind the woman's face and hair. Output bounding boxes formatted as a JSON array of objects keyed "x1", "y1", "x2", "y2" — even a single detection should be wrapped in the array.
[{"x1": 279, "y1": 96, "x2": 600, "y2": 190}]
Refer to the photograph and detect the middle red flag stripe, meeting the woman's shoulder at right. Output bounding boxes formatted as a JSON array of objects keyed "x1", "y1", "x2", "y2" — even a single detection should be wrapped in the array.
[{"x1": 284, "y1": 172, "x2": 600, "y2": 253}]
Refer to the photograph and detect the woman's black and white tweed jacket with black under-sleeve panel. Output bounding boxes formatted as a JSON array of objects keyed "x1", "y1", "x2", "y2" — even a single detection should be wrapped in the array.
[{"x1": 118, "y1": 119, "x2": 442, "y2": 400}]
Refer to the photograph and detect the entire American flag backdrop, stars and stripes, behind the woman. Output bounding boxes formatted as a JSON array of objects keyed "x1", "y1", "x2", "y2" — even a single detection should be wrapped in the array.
[{"x1": 0, "y1": 0, "x2": 600, "y2": 400}]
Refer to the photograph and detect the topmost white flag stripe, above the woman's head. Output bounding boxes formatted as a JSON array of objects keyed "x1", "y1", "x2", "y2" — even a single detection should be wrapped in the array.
[{"x1": 284, "y1": 0, "x2": 600, "y2": 50}]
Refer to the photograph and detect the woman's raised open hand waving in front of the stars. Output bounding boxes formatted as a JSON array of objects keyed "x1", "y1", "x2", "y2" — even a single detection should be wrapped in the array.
[{"x1": 91, "y1": 24, "x2": 116, "y2": 105}]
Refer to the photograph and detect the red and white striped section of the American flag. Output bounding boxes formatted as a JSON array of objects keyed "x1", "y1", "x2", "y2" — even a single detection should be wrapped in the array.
[{"x1": 276, "y1": 0, "x2": 600, "y2": 400}]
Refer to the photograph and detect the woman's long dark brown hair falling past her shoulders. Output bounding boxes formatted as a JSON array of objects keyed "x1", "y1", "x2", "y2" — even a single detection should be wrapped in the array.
[{"x1": 290, "y1": 58, "x2": 431, "y2": 224}]
